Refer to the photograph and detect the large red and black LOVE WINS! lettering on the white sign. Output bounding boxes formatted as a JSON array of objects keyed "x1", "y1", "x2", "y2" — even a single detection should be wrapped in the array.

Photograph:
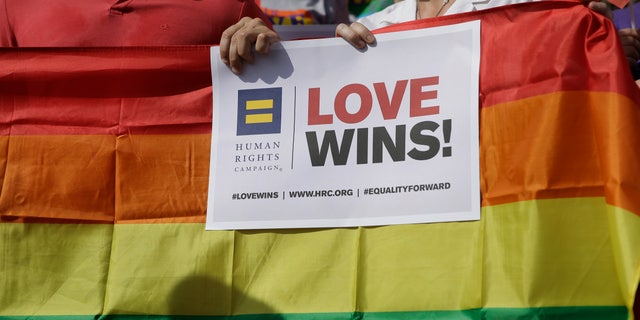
[{"x1": 306, "y1": 77, "x2": 452, "y2": 166}]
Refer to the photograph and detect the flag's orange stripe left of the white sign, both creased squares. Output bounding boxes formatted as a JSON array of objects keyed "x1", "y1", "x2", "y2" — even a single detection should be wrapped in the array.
[{"x1": 0, "y1": 134, "x2": 211, "y2": 223}]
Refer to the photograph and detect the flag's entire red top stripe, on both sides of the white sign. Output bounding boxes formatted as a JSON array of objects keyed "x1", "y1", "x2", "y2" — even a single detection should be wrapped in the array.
[{"x1": 0, "y1": 1, "x2": 640, "y2": 135}]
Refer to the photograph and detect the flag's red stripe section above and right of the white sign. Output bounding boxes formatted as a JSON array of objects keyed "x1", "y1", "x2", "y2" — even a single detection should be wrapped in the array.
[{"x1": 378, "y1": 0, "x2": 640, "y2": 107}]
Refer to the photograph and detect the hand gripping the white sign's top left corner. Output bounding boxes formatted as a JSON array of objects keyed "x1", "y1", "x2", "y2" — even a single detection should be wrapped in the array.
[{"x1": 220, "y1": 17, "x2": 280, "y2": 74}]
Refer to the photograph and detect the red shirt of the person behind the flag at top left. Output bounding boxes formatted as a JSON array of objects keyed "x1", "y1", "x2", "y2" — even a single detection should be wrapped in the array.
[{"x1": 0, "y1": 0, "x2": 270, "y2": 47}]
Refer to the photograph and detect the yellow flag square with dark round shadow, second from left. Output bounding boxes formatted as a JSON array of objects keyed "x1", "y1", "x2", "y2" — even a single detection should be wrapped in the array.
[{"x1": 105, "y1": 223, "x2": 239, "y2": 315}]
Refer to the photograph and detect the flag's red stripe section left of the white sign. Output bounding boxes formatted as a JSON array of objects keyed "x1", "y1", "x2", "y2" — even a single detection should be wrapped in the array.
[{"x1": 0, "y1": 46, "x2": 212, "y2": 135}]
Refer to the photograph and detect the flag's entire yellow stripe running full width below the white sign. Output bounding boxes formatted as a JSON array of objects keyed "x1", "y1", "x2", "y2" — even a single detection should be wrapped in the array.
[{"x1": 0, "y1": 197, "x2": 640, "y2": 315}]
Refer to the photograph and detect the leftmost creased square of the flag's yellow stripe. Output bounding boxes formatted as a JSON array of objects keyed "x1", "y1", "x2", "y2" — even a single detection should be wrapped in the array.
[{"x1": 0, "y1": 223, "x2": 113, "y2": 318}]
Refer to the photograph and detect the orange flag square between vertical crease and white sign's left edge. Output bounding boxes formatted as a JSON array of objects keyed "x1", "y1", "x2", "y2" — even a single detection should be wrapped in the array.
[{"x1": 116, "y1": 134, "x2": 211, "y2": 223}]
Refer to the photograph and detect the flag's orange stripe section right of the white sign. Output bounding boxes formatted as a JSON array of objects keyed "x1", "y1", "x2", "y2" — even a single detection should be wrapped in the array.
[{"x1": 480, "y1": 92, "x2": 640, "y2": 212}]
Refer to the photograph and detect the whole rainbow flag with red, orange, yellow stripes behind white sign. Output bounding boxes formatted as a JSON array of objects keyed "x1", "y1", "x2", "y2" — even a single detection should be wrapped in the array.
[{"x1": 0, "y1": 1, "x2": 640, "y2": 320}]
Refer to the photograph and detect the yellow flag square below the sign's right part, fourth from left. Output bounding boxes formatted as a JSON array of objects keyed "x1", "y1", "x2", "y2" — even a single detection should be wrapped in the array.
[{"x1": 357, "y1": 221, "x2": 482, "y2": 312}]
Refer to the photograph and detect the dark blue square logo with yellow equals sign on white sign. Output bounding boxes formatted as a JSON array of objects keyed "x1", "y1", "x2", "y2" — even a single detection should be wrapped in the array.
[{"x1": 236, "y1": 88, "x2": 282, "y2": 136}]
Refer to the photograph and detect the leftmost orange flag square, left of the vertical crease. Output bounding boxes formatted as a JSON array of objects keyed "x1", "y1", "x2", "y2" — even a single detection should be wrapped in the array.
[{"x1": 0, "y1": 135, "x2": 115, "y2": 222}]
